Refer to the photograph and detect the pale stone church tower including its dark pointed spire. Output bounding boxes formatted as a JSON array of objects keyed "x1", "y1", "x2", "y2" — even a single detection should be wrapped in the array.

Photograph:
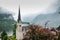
[{"x1": 16, "y1": 7, "x2": 23, "y2": 40}]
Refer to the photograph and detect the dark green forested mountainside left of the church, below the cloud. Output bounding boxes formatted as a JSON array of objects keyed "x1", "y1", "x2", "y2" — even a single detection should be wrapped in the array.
[{"x1": 0, "y1": 14, "x2": 16, "y2": 32}]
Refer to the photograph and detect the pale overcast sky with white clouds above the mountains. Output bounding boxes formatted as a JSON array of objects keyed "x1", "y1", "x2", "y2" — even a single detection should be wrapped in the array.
[{"x1": 0, "y1": 0, "x2": 58, "y2": 19}]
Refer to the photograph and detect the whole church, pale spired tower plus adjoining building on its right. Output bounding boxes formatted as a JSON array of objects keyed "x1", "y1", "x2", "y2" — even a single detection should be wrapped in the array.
[{"x1": 16, "y1": 7, "x2": 29, "y2": 40}]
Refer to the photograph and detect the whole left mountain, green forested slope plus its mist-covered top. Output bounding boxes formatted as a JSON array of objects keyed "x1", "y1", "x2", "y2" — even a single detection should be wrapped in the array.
[{"x1": 0, "y1": 7, "x2": 16, "y2": 35}]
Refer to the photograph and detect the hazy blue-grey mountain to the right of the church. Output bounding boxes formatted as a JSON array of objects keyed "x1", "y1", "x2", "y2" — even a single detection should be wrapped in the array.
[{"x1": 32, "y1": 13, "x2": 60, "y2": 28}]
